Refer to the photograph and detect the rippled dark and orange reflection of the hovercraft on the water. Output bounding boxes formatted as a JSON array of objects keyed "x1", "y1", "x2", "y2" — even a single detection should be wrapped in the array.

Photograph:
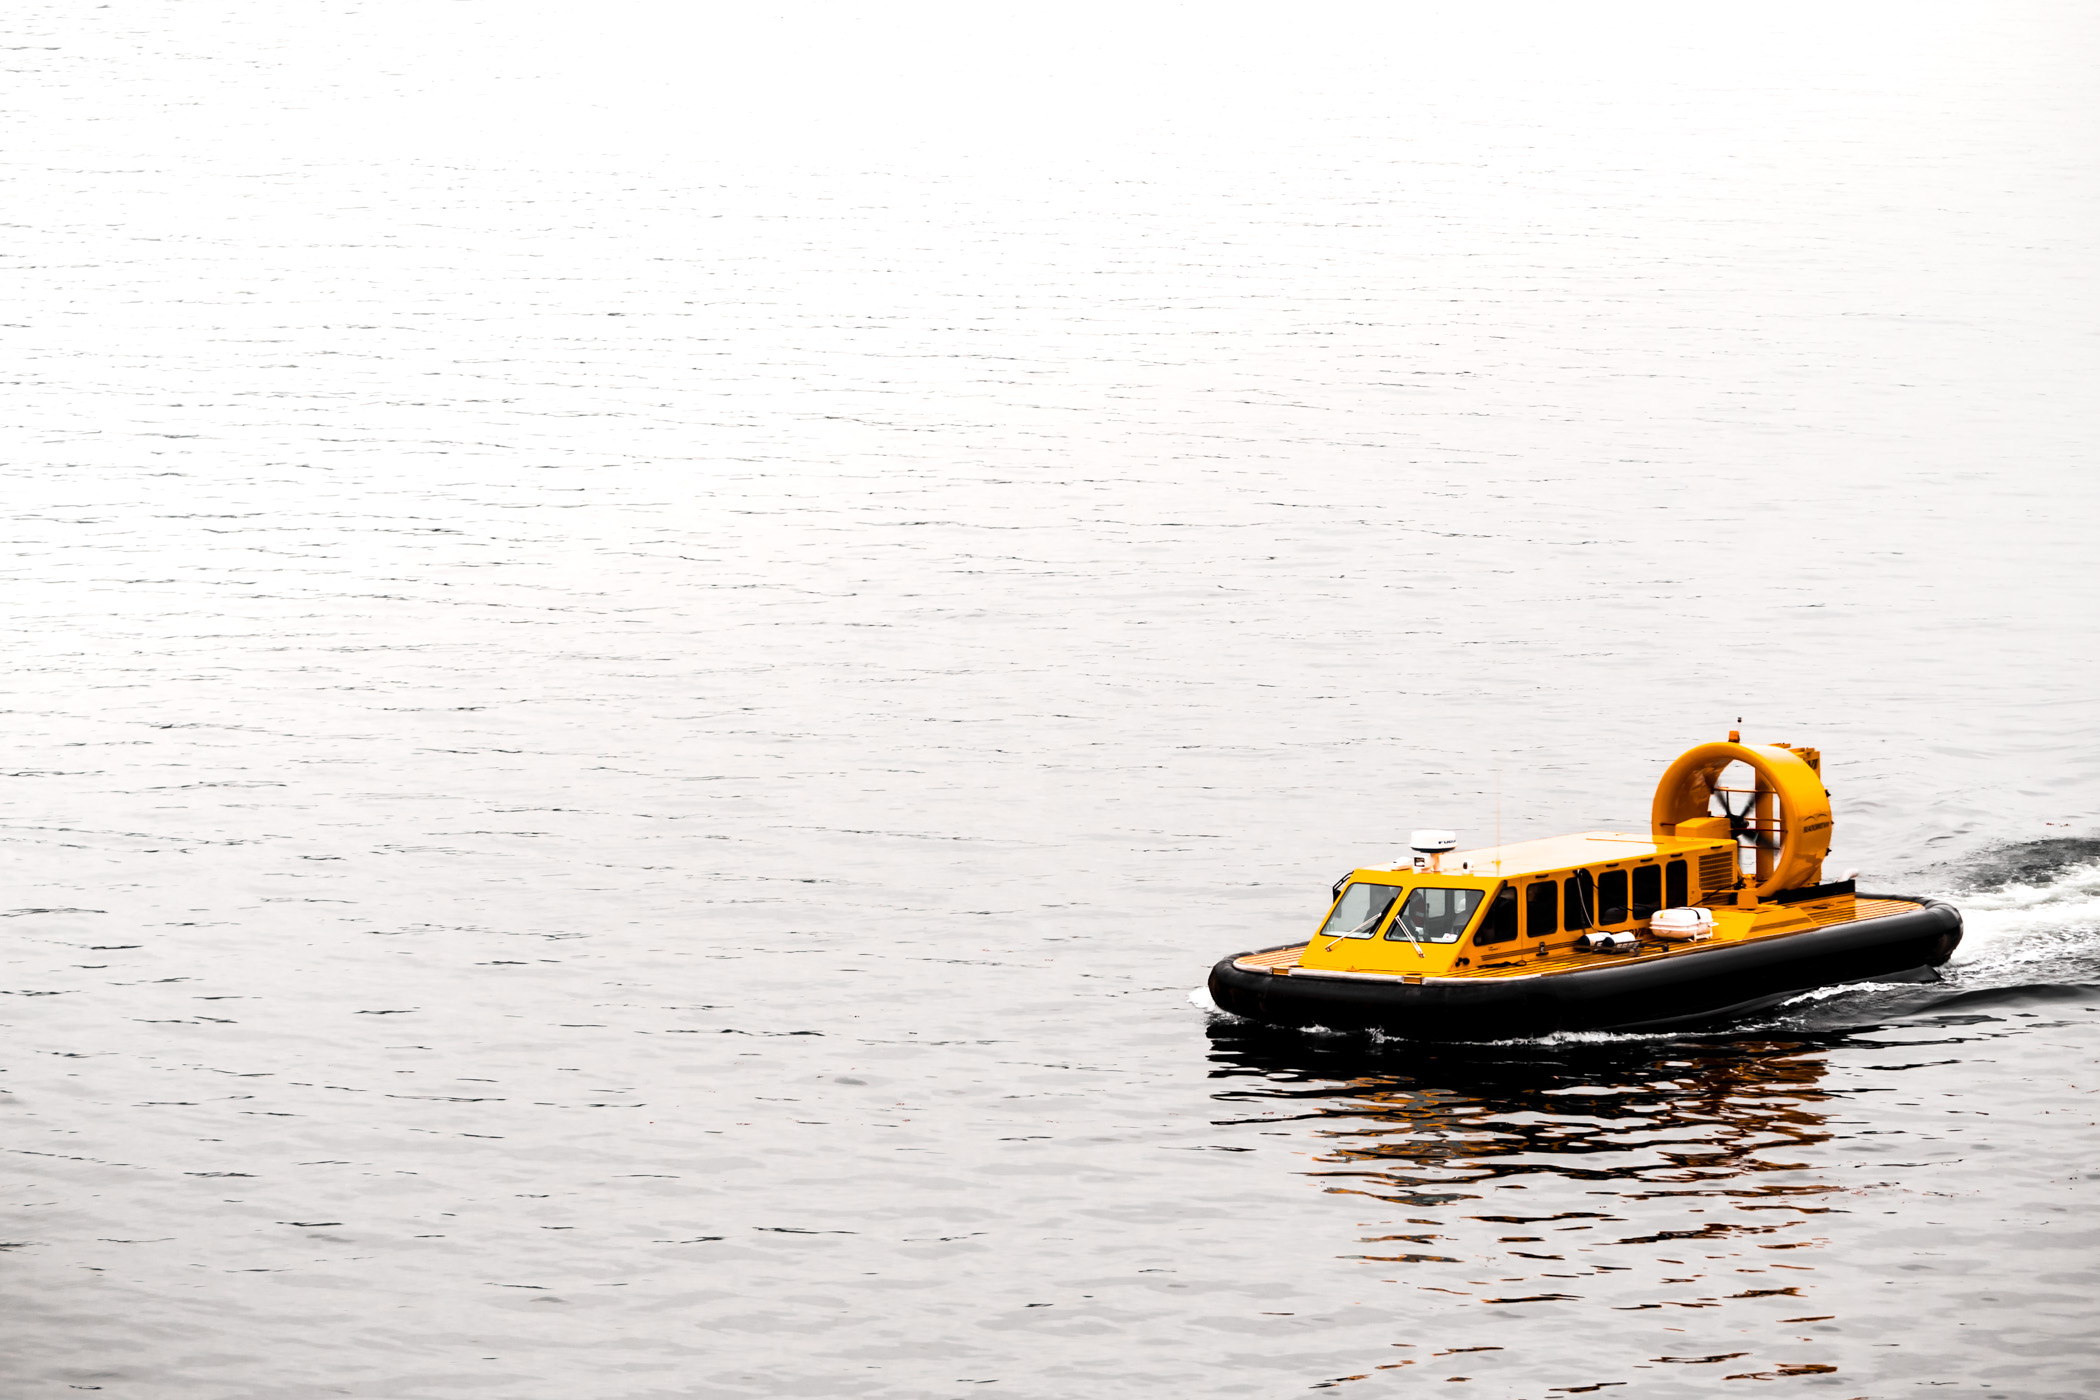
[{"x1": 1210, "y1": 1020, "x2": 1923, "y2": 1385}]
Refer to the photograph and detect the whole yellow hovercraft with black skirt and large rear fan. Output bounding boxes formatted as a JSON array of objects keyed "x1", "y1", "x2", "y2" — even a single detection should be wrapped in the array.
[{"x1": 1210, "y1": 733, "x2": 1961, "y2": 1041}]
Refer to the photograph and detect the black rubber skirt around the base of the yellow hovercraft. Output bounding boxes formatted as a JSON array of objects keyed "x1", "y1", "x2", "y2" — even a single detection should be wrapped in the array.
[{"x1": 1210, "y1": 896, "x2": 1961, "y2": 1041}]
